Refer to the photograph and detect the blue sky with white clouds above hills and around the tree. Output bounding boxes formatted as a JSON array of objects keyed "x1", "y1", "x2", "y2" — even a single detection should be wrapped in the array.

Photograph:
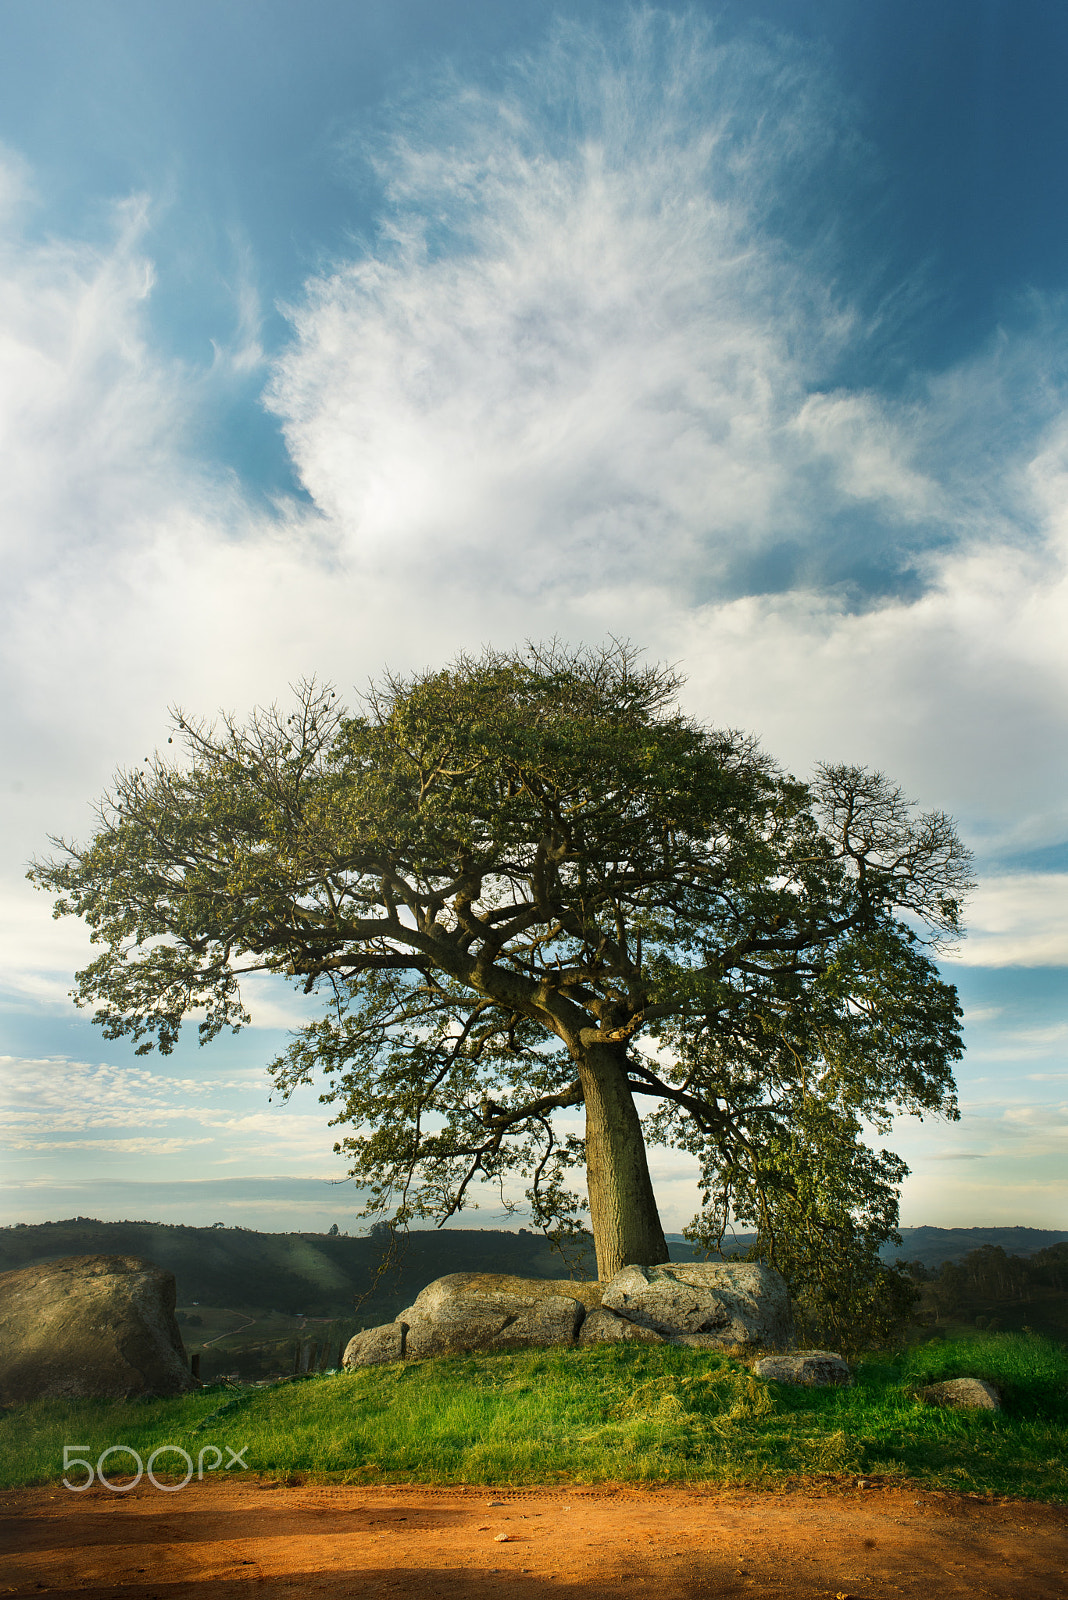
[{"x1": 0, "y1": 0, "x2": 1068, "y2": 1230}]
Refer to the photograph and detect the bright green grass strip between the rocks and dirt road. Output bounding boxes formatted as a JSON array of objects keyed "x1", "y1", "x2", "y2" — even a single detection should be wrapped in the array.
[{"x1": 0, "y1": 1334, "x2": 1068, "y2": 1501}]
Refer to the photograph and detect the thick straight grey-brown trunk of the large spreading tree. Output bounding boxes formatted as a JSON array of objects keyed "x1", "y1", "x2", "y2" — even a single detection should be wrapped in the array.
[{"x1": 579, "y1": 1045, "x2": 670, "y2": 1283}]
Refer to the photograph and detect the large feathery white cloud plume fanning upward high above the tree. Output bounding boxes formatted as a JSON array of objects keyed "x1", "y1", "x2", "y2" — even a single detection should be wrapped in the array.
[{"x1": 269, "y1": 13, "x2": 943, "y2": 605}]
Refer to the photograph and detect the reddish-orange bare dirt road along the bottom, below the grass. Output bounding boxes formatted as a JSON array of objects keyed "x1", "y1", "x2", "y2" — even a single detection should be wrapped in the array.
[{"x1": 0, "y1": 1474, "x2": 1068, "y2": 1600}]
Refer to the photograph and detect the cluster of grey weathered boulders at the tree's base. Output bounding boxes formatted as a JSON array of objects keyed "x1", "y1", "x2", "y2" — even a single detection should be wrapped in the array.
[{"x1": 344, "y1": 1262, "x2": 793, "y2": 1370}]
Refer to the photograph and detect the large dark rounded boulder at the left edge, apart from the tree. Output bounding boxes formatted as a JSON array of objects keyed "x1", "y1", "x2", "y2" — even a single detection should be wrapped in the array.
[{"x1": 0, "y1": 1256, "x2": 197, "y2": 1405}]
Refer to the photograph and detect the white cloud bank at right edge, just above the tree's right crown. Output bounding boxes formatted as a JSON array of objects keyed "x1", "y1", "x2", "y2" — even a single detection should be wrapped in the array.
[{"x1": 676, "y1": 512, "x2": 1068, "y2": 848}]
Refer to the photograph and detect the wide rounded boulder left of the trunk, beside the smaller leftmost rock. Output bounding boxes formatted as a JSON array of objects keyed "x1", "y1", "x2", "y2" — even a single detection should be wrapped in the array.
[{"x1": 398, "y1": 1272, "x2": 588, "y2": 1360}]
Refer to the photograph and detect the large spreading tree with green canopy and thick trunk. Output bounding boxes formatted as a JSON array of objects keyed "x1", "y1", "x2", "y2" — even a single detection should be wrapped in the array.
[{"x1": 30, "y1": 645, "x2": 967, "y2": 1277}]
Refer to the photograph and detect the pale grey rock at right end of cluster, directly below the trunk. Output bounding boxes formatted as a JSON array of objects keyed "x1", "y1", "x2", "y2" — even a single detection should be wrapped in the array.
[{"x1": 601, "y1": 1261, "x2": 793, "y2": 1349}]
